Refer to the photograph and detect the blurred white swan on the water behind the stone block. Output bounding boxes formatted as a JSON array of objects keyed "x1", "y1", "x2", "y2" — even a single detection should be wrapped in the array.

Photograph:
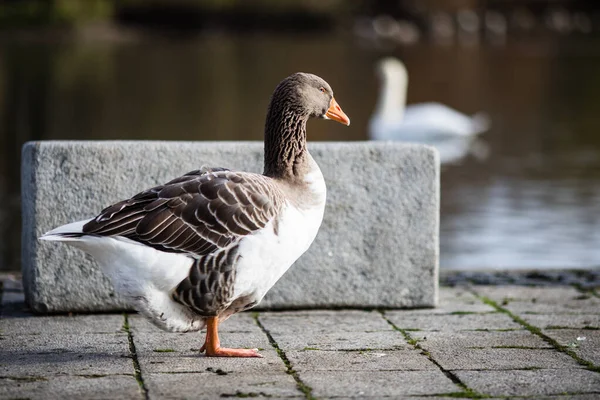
[{"x1": 369, "y1": 57, "x2": 489, "y2": 162}]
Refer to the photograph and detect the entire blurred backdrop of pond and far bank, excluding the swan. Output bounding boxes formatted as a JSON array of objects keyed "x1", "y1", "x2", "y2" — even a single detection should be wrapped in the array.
[{"x1": 0, "y1": 0, "x2": 600, "y2": 271}]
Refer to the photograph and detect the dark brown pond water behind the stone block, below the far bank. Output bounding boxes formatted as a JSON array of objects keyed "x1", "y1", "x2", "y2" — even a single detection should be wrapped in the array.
[{"x1": 0, "y1": 31, "x2": 600, "y2": 269}]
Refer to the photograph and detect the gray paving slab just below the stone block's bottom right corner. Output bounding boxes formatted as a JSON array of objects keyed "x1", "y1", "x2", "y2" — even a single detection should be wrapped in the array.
[{"x1": 385, "y1": 311, "x2": 522, "y2": 331}]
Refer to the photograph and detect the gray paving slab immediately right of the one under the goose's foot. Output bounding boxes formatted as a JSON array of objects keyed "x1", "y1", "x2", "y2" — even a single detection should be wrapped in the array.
[{"x1": 286, "y1": 350, "x2": 439, "y2": 376}]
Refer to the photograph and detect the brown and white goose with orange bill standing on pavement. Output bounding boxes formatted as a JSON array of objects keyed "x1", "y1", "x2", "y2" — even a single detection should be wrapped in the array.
[{"x1": 40, "y1": 72, "x2": 350, "y2": 357}]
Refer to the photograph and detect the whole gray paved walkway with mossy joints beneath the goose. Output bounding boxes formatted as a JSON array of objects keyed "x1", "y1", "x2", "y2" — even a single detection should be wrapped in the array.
[{"x1": 0, "y1": 276, "x2": 600, "y2": 399}]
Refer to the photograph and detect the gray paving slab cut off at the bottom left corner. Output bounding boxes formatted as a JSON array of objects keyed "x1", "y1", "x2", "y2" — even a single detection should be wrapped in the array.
[{"x1": 0, "y1": 375, "x2": 143, "y2": 400}]
